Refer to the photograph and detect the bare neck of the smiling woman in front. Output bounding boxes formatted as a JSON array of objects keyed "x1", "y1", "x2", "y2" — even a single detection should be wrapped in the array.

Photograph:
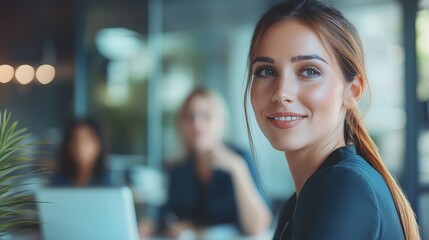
[{"x1": 285, "y1": 133, "x2": 345, "y2": 197}]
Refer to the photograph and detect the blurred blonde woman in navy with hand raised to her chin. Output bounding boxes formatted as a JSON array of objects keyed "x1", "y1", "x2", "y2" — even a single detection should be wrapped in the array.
[{"x1": 164, "y1": 88, "x2": 271, "y2": 236}]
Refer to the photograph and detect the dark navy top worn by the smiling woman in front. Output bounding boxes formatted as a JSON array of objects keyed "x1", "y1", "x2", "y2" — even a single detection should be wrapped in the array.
[{"x1": 274, "y1": 145, "x2": 405, "y2": 240}]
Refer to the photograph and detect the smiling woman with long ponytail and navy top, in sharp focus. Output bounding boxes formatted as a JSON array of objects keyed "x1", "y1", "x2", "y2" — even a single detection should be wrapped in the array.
[{"x1": 245, "y1": 0, "x2": 420, "y2": 240}]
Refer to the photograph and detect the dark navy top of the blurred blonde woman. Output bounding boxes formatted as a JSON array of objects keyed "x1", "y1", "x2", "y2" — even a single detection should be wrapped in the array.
[{"x1": 163, "y1": 145, "x2": 261, "y2": 232}]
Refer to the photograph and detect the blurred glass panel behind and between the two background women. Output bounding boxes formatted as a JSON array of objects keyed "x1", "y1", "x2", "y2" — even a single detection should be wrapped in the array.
[{"x1": 84, "y1": 0, "x2": 150, "y2": 156}]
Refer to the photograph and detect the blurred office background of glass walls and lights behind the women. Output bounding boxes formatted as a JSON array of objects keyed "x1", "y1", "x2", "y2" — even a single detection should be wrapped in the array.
[{"x1": 0, "y1": 0, "x2": 429, "y2": 238}]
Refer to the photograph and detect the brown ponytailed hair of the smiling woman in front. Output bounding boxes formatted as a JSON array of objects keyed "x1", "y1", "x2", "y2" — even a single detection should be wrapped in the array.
[{"x1": 244, "y1": 0, "x2": 420, "y2": 240}]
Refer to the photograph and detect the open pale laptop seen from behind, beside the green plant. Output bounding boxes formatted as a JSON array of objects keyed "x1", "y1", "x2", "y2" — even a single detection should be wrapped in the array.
[{"x1": 36, "y1": 187, "x2": 139, "y2": 240}]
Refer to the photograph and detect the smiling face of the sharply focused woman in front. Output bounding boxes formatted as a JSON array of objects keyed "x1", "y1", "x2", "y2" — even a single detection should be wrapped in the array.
[{"x1": 251, "y1": 20, "x2": 346, "y2": 152}]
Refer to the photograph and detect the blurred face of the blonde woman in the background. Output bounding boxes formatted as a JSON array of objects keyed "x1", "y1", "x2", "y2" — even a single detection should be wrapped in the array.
[{"x1": 181, "y1": 96, "x2": 223, "y2": 152}]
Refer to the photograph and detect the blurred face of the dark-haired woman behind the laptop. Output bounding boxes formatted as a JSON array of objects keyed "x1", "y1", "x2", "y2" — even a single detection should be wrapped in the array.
[{"x1": 69, "y1": 125, "x2": 101, "y2": 166}]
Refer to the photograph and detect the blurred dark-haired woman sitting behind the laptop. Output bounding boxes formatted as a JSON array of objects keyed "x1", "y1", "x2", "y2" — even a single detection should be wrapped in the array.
[{"x1": 52, "y1": 119, "x2": 111, "y2": 187}]
